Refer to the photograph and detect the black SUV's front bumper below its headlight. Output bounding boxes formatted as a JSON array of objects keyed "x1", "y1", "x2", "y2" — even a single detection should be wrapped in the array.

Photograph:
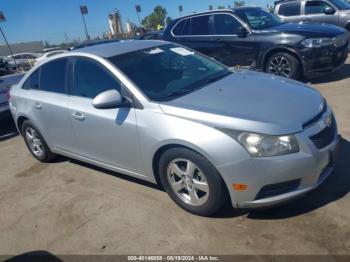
[{"x1": 300, "y1": 43, "x2": 348, "y2": 77}]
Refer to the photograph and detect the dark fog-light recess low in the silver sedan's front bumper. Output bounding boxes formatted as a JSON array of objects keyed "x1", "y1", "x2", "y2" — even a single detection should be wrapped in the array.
[{"x1": 255, "y1": 179, "x2": 301, "y2": 200}]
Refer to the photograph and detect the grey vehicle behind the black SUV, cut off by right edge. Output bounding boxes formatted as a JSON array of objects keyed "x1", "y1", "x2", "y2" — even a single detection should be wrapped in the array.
[{"x1": 274, "y1": 0, "x2": 350, "y2": 31}]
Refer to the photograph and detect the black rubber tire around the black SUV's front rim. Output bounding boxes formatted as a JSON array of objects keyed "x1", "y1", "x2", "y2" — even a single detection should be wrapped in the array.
[{"x1": 265, "y1": 52, "x2": 302, "y2": 80}]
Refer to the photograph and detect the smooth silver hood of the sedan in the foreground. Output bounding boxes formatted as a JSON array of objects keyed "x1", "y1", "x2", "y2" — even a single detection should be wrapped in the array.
[{"x1": 160, "y1": 70, "x2": 324, "y2": 135}]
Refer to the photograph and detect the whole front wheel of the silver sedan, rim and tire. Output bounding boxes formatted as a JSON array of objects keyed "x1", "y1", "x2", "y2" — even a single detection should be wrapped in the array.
[{"x1": 159, "y1": 148, "x2": 227, "y2": 216}]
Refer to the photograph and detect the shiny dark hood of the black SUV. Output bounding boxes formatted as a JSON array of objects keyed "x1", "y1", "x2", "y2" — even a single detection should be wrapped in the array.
[{"x1": 266, "y1": 23, "x2": 346, "y2": 37}]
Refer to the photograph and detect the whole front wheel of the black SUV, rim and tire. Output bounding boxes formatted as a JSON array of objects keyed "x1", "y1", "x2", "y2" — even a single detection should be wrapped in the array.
[{"x1": 265, "y1": 52, "x2": 301, "y2": 79}]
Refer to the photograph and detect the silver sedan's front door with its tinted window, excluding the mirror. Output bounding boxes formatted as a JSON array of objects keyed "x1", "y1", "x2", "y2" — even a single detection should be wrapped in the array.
[{"x1": 70, "y1": 57, "x2": 142, "y2": 173}]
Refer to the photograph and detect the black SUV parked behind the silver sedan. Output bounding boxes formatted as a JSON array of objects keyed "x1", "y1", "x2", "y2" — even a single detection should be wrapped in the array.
[{"x1": 163, "y1": 7, "x2": 348, "y2": 79}]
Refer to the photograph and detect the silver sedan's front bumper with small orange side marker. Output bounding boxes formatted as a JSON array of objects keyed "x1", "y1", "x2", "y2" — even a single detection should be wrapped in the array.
[{"x1": 218, "y1": 111, "x2": 340, "y2": 208}]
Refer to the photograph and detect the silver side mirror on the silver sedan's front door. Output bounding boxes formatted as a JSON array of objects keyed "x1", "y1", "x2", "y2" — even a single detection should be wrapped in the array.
[{"x1": 92, "y1": 89, "x2": 131, "y2": 109}]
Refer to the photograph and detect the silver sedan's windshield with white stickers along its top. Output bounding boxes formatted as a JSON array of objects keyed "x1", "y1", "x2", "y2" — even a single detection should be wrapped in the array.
[{"x1": 109, "y1": 44, "x2": 231, "y2": 101}]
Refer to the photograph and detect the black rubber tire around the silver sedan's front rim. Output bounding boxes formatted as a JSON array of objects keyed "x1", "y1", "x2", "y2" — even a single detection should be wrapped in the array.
[{"x1": 158, "y1": 147, "x2": 228, "y2": 216}]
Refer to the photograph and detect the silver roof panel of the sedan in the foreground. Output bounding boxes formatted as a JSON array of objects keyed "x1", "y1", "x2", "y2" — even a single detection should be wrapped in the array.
[{"x1": 74, "y1": 40, "x2": 168, "y2": 58}]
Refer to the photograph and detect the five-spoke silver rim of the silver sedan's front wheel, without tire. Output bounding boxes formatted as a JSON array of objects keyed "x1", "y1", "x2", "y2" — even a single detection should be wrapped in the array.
[{"x1": 167, "y1": 158, "x2": 209, "y2": 206}]
